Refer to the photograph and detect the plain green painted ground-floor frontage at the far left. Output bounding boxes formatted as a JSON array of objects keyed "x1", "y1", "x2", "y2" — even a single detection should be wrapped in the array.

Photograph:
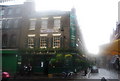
[{"x1": 2, "y1": 50, "x2": 18, "y2": 74}]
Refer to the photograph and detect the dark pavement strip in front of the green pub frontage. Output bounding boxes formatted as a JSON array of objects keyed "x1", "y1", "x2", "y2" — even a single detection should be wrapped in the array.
[{"x1": 10, "y1": 70, "x2": 90, "y2": 80}]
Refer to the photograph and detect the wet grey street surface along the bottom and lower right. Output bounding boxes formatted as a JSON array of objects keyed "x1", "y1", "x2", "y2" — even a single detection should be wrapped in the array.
[{"x1": 10, "y1": 68, "x2": 119, "y2": 81}]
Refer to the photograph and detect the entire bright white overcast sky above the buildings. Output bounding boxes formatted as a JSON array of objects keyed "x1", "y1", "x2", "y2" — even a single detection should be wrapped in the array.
[{"x1": 0, "y1": 0, "x2": 119, "y2": 54}]
